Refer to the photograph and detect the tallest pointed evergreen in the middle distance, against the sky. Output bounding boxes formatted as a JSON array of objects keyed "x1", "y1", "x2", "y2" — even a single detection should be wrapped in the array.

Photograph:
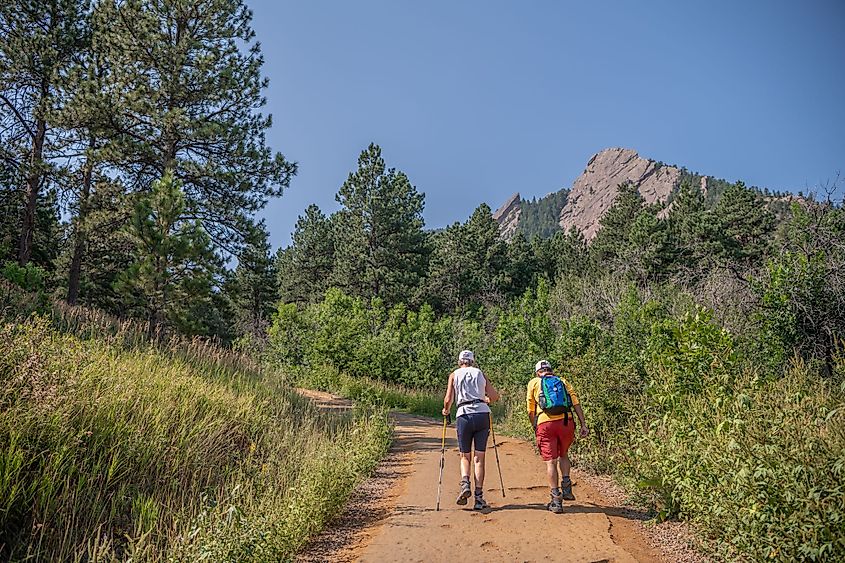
[{"x1": 335, "y1": 144, "x2": 428, "y2": 305}]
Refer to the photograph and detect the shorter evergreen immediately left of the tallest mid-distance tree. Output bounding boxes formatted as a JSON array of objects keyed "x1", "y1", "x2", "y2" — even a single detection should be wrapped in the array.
[{"x1": 276, "y1": 204, "x2": 334, "y2": 304}]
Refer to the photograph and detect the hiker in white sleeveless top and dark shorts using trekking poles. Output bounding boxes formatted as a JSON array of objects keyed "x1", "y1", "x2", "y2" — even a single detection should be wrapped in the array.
[{"x1": 443, "y1": 350, "x2": 499, "y2": 510}]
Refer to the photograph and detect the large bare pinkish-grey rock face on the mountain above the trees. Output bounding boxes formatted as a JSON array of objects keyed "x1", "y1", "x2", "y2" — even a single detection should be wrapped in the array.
[{"x1": 560, "y1": 148, "x2": 681, "y2": 240}]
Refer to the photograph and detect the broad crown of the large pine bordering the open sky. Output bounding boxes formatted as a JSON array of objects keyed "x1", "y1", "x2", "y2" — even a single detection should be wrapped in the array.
[{"x1": 94, "y1": 0, "x2": 296, "y2": 254}]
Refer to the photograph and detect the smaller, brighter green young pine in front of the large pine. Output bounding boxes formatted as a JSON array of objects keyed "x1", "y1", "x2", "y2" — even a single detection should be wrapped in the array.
[{"x1": 118, "y1": 172, "x2": 221, "y2": 334}]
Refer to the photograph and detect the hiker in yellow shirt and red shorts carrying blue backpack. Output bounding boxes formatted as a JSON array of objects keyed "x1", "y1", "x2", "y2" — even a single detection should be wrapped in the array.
[{"x1": 526, "y1": 360, "x2": 590, "y2": 514}]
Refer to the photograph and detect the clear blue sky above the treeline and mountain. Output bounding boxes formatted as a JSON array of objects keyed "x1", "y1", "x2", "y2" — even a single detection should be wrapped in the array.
[{"x1": 247, "y1": 0, "x2": 845, "y2": 246}]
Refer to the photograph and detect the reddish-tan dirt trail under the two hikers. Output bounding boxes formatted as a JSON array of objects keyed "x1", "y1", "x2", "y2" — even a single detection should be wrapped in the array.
[{"x1": 300, "y1": 392, "x2": 664, "y2": 562}]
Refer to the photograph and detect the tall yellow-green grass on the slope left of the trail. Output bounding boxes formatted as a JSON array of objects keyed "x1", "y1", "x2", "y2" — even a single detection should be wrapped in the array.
[{"x1": 0, "y1": 307, "x2": 390, "y2": 561}]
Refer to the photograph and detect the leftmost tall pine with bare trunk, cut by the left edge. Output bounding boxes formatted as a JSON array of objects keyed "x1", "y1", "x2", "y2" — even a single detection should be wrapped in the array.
[{"x1": 0, "y1": 0, "x2": 88, "y2": 265}]
